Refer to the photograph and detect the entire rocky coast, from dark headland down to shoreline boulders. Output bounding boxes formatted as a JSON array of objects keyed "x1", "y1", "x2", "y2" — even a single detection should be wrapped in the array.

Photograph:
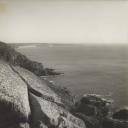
[{"x1": 0, "y1": 42, "x2": 128, "y2": 128}]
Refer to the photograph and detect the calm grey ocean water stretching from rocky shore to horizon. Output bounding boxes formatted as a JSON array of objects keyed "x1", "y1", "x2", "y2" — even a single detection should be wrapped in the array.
[{"x1": 17, "y1": 44, "x2": 128, "y2": 107}]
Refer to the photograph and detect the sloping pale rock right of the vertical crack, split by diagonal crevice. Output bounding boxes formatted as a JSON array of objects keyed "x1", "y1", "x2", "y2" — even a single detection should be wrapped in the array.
[{"x1": 13, "y1": 63, "x2": 85, "y2": 128}]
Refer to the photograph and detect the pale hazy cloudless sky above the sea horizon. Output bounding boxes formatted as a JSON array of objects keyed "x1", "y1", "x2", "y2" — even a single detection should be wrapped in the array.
[{"x1": 0, "y1": 0, "x2": 128, "y2": 43}]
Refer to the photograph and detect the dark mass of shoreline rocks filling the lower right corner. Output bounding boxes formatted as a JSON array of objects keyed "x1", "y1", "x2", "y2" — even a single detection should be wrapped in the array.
[{"x1": 73, "y1": 94, "x2": 128, "y2": 128}]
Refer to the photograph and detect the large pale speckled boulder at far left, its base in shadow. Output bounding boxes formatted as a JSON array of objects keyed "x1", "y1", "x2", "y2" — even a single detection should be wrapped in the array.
[{"x1": 0, "y1": 60, "x2": 31, "y2": 128}]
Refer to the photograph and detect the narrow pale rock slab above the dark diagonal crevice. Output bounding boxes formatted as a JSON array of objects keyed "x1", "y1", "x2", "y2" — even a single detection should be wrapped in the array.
[{"x1": 12, "y1": 66, "x2": 63, "y2": 104}]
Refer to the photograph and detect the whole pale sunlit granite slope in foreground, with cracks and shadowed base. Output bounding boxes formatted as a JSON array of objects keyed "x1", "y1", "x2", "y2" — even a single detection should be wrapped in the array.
[{"x1": 0, "y1": 60, "x2": 86, "y2": 128}]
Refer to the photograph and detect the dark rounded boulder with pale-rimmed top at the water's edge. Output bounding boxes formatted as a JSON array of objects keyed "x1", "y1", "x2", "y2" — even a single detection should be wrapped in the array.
[{"x1": 75, "y1": 94, "x2": 111, "y2": 118}]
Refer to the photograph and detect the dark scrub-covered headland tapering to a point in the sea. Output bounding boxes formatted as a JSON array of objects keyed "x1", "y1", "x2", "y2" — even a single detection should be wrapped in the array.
[{"x1": 0, "y1": 42, "x2": 61, "y2": 76}]
